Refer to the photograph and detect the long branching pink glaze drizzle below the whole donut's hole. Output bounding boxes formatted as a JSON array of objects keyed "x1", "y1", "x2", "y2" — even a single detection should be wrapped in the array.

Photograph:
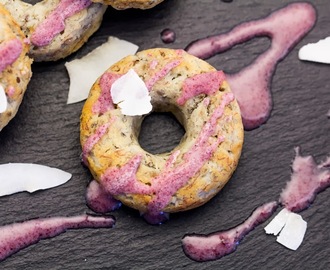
[{"x1": 100, "y1": 93, "x2": 234, "y2": 223}]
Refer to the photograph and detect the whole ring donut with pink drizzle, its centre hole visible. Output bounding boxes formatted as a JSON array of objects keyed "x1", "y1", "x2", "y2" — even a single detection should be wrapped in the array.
[{"x1": 80, "y1": 48, "x2": 244, "y2": 220}]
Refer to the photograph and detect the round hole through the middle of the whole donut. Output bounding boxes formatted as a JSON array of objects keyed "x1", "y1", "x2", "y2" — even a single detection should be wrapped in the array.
[{"x1": 138, "y1": 112, "x2": 186, "y2": 154}]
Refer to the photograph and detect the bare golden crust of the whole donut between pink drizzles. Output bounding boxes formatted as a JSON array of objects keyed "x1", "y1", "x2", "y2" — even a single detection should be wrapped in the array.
[{"x1": 80, "y1": 49, "x2": 243, "y2": 212}]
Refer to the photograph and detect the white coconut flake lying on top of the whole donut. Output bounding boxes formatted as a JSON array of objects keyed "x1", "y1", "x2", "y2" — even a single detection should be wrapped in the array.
[{"x1": 110, "y1": 69, "x2": 152, "y2": 116}]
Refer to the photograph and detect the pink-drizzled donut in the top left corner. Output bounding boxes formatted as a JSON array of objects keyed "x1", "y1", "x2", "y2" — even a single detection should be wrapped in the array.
[{"x1": 1, "y1": 0, "x2": 107, "y2": 62}]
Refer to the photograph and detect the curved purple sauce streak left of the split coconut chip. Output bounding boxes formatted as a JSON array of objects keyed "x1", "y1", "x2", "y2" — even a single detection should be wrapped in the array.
[{"x1": 182, "y1": 202, "x2": 278, "y2": 262}]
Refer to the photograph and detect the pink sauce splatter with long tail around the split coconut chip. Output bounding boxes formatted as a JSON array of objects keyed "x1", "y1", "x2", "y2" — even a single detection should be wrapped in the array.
[{"x1": 182, "y1": 148, "x2": 330, "y2": 261}]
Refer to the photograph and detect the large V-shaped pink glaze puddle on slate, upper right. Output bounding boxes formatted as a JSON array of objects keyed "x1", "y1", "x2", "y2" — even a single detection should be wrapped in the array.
[{"x1": 186, "y1": 3, "x2": 316, "y2": 130}]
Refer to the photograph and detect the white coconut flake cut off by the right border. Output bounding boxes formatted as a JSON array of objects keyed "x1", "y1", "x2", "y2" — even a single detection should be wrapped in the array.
[{"x1": 298, "y1": 37, "x2": 330, "y2": 64}]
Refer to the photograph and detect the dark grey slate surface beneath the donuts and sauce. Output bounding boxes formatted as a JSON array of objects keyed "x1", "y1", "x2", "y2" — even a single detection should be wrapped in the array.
[{"x1": 0, "y1": 0, "x2": 330, "y2": 269}]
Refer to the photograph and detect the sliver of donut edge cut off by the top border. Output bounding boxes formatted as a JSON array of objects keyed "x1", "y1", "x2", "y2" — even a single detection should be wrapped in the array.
[{"x1": 92, "y1": 0, "x2": 164, "y2": 9}]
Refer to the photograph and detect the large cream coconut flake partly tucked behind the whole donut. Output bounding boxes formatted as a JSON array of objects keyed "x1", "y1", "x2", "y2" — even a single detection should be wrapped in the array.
[{"x1": 65, "y1": 37, "x2": 138, "y2": 104}]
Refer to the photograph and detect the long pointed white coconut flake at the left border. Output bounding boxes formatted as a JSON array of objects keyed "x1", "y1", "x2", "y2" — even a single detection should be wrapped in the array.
[{"x1": 0, "y1": 163, "x2": 72, "y2": 196}]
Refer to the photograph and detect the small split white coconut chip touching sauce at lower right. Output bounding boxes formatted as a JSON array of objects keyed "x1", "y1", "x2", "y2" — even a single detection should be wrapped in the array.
[{"x1": 265, "y1": 208, "x2": 307, "y2": 250}]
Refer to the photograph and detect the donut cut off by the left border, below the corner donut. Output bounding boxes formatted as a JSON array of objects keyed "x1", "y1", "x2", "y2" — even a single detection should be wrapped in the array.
[{"x1": 0, "y1": 4, "x2": 32, "y2": 131}]
